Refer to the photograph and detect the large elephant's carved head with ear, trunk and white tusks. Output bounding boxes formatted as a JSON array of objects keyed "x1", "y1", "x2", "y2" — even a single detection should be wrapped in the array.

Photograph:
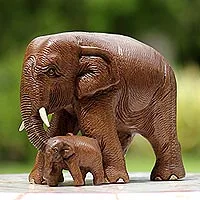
[{"x1": 20, "y1": 34, "x2": 119, "y2": 151}]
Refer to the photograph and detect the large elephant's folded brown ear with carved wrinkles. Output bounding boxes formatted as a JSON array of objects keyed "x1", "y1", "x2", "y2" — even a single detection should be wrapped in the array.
[{"x1": 77, "y1": 46, "x2": 119, "y2": 99}]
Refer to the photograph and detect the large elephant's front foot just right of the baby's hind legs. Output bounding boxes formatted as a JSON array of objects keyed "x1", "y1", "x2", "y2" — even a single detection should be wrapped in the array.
[{"x1": 105, "y1": 166, "x2": 129, "y2": 183}]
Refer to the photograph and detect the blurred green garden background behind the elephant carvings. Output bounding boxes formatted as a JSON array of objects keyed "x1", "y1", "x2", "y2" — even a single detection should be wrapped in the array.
[{"x1": 0, "y1": 0, "x2": 200, "y2": 173}]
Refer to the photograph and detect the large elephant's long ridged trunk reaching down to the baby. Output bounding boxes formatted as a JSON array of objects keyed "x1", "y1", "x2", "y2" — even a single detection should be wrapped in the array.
[{"x1": 20, "y1": 56, "x2": 49, "y2": 151}]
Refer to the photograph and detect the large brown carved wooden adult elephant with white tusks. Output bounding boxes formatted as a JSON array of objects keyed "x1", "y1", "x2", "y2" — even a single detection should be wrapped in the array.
[{"x1": 21, "y1": 32, "x2": 185, "y2": 183}]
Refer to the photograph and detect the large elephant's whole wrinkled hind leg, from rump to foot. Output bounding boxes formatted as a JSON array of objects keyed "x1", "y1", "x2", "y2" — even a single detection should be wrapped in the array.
[{"x1": 144, "y1": 82, "x2": 185, "y2": 180}]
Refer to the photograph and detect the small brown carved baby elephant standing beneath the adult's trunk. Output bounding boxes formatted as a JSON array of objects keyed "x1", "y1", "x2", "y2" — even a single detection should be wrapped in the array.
[{"x1": 44, "y1": 134, "x2": 104, "y2": 186}]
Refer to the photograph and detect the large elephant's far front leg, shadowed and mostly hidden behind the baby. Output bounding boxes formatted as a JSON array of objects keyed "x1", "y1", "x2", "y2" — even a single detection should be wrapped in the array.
[{"x1": 29, "y1": 110, "x2": 78, "y2": 184}]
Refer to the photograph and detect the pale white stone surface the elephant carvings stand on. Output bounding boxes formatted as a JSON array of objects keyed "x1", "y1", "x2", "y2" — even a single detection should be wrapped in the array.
[{"x1": 0, "y1": 172, "x2": 200, "y2": 200}]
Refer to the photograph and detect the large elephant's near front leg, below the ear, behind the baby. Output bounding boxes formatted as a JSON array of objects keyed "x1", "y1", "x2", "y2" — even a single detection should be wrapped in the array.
[{"x1": 79, "y1": 99, "x2": 129, "y2": 183}]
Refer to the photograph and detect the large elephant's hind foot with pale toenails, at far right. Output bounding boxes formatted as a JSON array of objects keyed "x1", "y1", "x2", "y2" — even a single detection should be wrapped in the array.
[{"x1": 150, "y1": 160, "x2": 185, "y2": 181}]
